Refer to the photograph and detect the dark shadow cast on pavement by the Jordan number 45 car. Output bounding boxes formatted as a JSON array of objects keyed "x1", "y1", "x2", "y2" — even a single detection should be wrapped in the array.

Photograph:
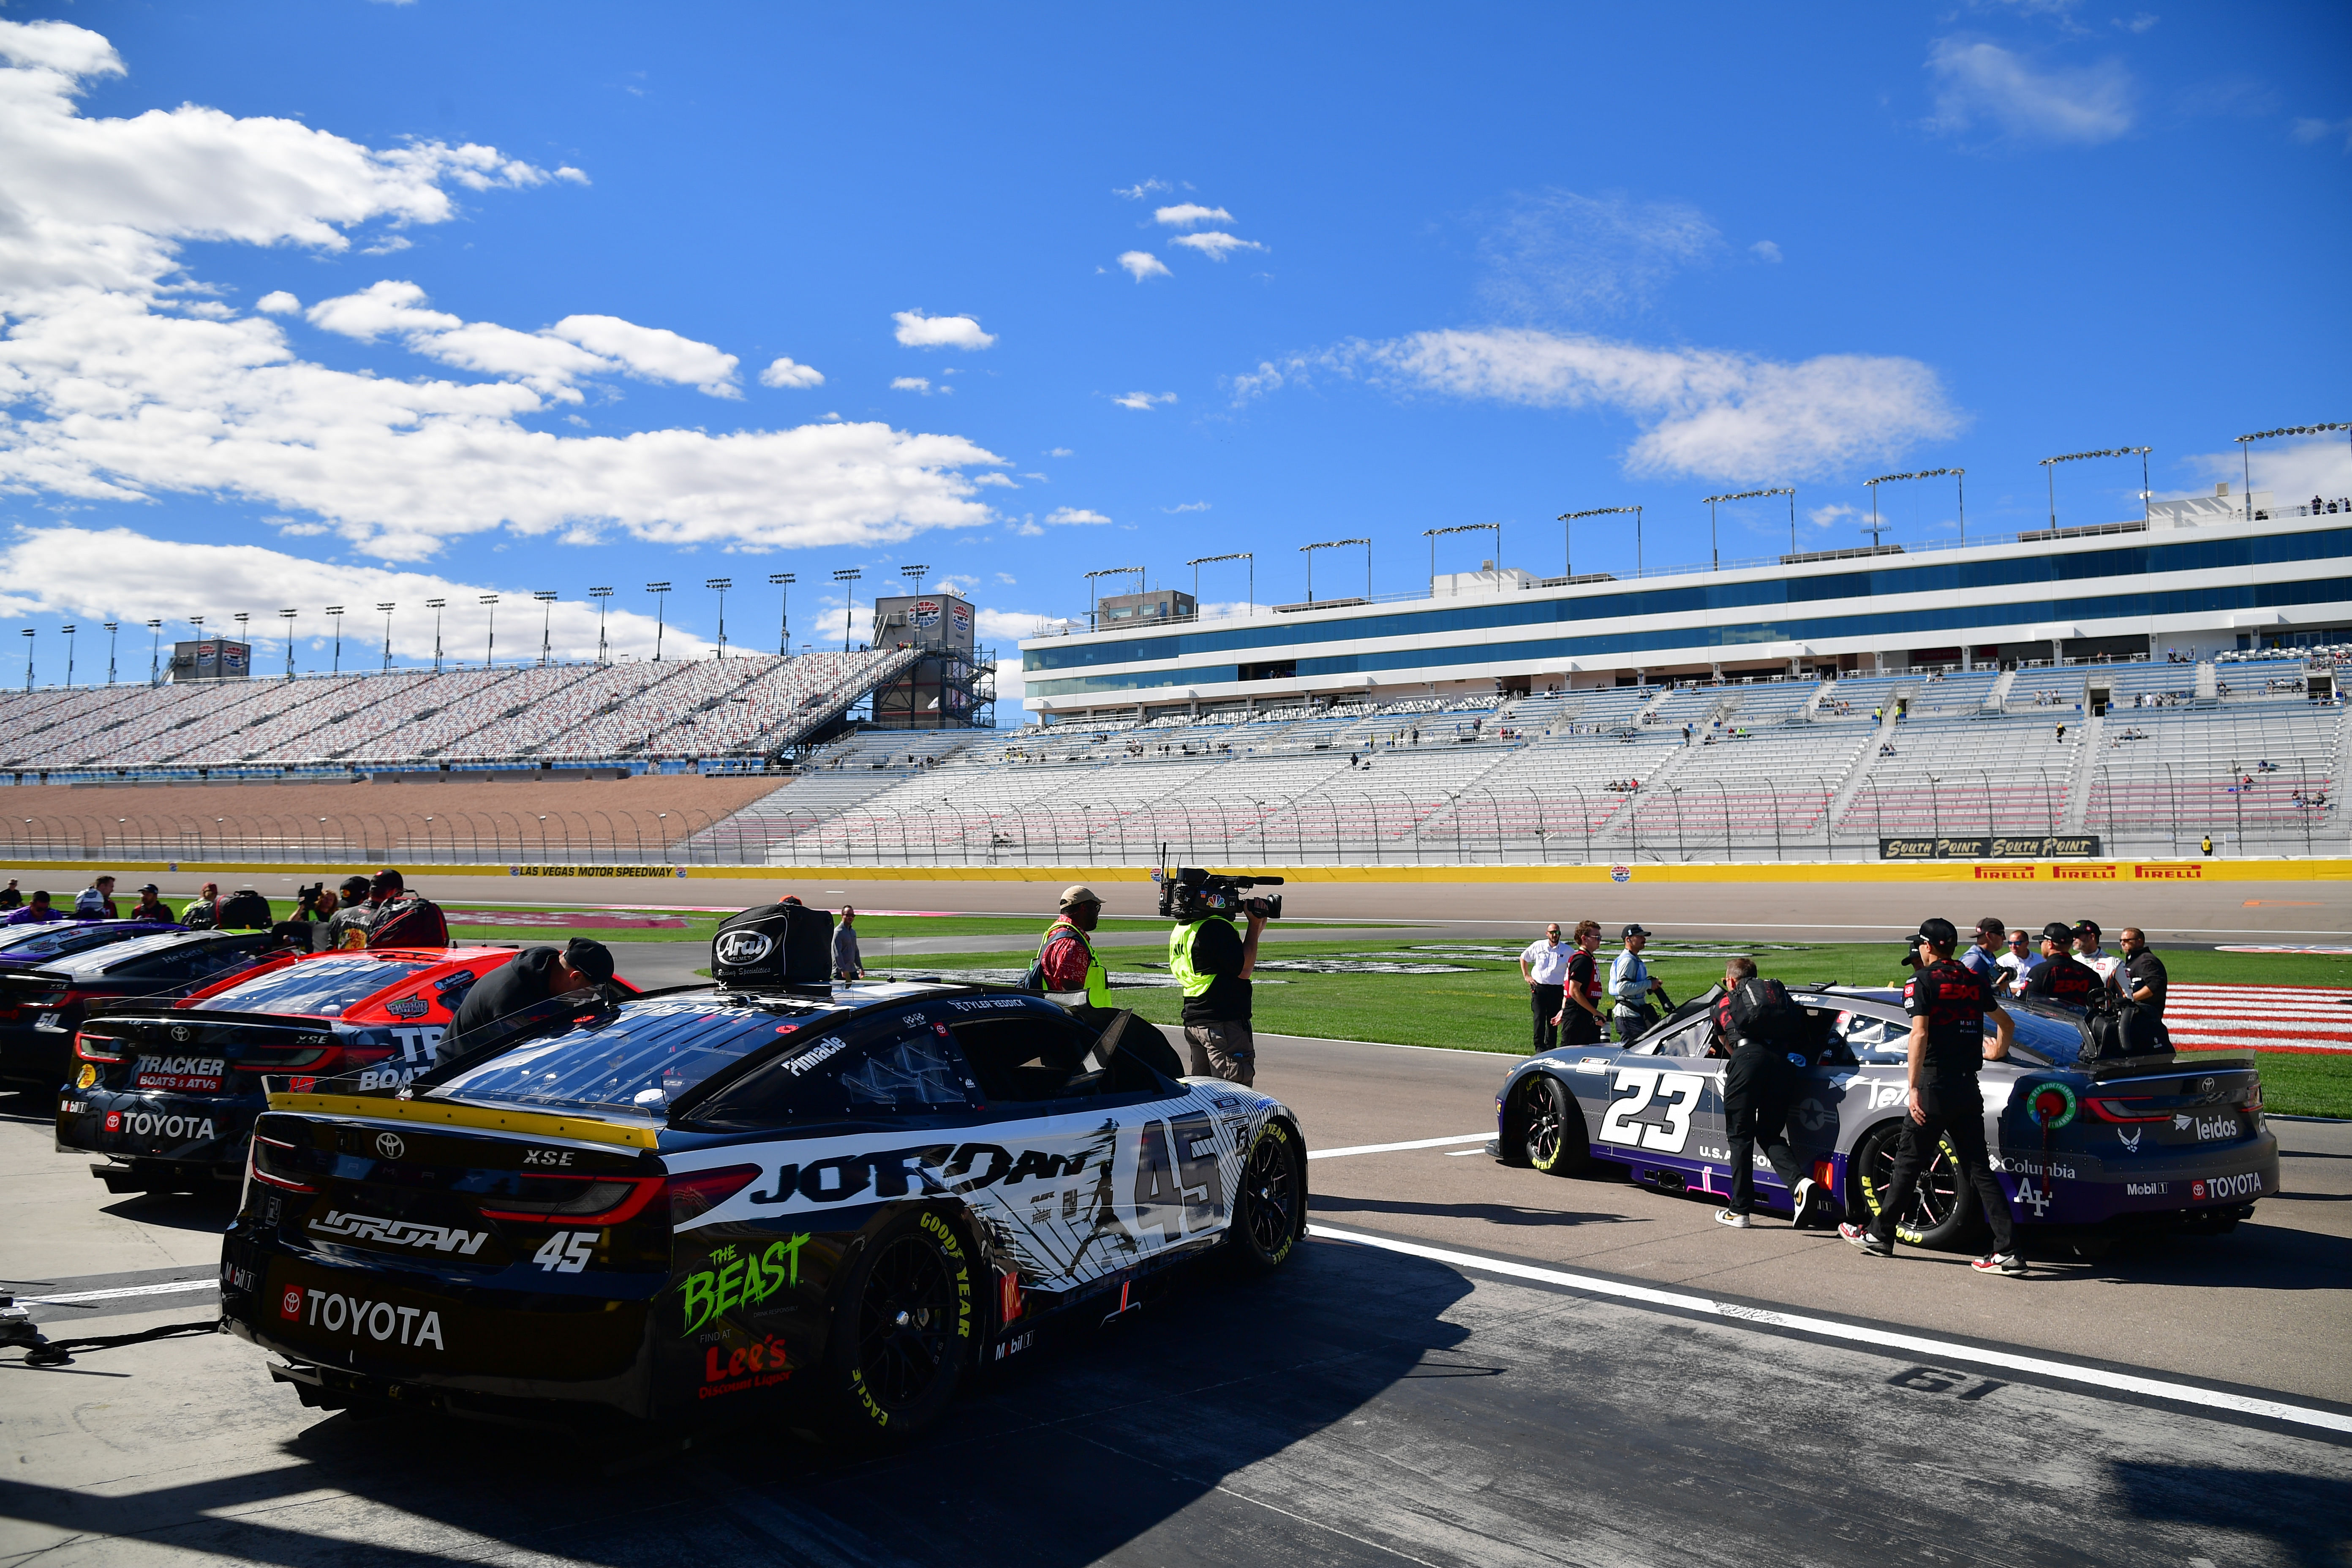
[{"x1": 0, "y1": 1241, "x2": 1467, "y2": 1568}]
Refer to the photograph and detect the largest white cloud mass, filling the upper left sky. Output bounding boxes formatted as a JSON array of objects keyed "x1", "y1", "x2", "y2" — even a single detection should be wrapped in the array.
[{"x1": 0, "y1": 21, "x2": 1002, "y2": 560}]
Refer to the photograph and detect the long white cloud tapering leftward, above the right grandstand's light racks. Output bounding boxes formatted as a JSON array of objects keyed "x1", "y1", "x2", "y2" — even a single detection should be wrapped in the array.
[{"x1": 1233, "y1": 329, "x2": 1964, "y2": 479}]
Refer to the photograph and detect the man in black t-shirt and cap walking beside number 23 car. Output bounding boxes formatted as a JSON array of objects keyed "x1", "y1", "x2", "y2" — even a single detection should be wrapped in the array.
[{"x1": 1837, "y1": 917, "x2": 2023, "y2": 1274}]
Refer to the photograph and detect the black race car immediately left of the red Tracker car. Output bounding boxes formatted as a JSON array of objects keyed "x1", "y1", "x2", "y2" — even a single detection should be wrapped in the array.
[{"x1": 0, "y1": 931, "x2": 278, "y2": 1089}]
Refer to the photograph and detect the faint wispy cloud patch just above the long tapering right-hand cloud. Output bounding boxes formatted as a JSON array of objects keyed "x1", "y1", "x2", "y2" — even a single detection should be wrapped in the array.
[{"x1": 1479, "y1": 188, "x2": 1722, "y2": 322}]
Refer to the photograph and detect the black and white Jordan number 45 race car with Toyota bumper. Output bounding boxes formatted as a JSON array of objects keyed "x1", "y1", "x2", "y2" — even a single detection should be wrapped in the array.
[{"x1": 221, "y1": 983, "x2": 1305, "y2": 1441}]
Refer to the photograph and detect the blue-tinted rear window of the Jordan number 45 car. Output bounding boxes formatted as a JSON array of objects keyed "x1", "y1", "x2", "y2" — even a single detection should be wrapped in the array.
[{"x1": 430, "y1": 1002, "x2": 809, "y2": 1119}]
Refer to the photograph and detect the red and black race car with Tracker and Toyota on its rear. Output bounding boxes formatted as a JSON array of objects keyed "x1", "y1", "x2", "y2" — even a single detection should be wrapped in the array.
[{"x1": 57, "y1": 947, "x2": 637, "y2": 1194}]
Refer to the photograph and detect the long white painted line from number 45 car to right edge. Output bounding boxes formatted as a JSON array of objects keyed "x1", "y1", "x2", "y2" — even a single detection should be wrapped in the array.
[{"x1": 1308, "y1": 1225, "x2": 2352, "y2": 1434}]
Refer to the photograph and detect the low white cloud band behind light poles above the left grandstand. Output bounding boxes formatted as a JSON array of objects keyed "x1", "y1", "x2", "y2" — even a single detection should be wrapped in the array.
[{"x1": 0, "y1": 524, "x2": 708, "y2": 668}]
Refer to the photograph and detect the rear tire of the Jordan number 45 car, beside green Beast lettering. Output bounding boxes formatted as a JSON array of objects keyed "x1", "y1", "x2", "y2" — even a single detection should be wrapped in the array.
[{"x1": 823, "y1": 1209, "x2": 978, "y2": 1451}]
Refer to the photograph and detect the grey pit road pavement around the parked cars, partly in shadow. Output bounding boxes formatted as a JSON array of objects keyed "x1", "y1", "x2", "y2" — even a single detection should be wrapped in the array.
[{"x1": 0, "y1": 1037, "x2": 2352, "y2": 1565}]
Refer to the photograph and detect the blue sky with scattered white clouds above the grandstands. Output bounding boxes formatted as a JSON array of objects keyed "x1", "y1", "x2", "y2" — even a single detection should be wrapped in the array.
[{"x1": 0, "y1": 0, "x2": 2352, "y2": 700}]
